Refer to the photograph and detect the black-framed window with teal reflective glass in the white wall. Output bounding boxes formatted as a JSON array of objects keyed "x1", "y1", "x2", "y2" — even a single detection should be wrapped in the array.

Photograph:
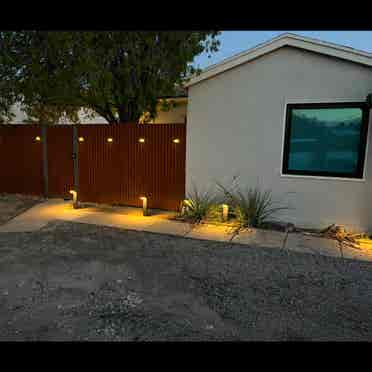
[{"x1": 282, "y1": 103, "x2": 368, "y2": 178}]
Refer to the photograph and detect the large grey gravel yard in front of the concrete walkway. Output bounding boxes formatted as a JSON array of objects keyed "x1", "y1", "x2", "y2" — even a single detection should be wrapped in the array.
[{"x1": 0, "y1": 222, "x2": 372, "y2": 341}]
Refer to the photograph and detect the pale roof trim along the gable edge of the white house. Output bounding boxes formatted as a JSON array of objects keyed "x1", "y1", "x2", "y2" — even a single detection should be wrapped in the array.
[{"x1": 184, "y1": 33, "x2": 372, "y2": 88}]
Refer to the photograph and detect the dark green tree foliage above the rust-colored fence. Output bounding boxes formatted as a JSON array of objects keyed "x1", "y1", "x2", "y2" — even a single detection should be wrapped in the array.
[{"x1": 0, "y1": 31, "x2": 219, "y2": 123}]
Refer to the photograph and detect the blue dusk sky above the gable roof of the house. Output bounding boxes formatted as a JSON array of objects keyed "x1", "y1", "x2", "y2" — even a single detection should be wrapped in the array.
[{"x1": 194, "y1": 31, "x2": 372, "y2": 68}]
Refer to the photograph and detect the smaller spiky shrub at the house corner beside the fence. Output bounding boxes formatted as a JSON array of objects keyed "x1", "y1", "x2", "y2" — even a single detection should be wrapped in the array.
[{"x1": 181, "y1": 186, "x2": 218, "y2": 223}]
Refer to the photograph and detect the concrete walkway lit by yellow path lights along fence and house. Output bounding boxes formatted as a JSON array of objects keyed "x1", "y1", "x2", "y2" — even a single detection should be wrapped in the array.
[{"x1": 0, "y1": 199, "x2": 372, "y2": 261}]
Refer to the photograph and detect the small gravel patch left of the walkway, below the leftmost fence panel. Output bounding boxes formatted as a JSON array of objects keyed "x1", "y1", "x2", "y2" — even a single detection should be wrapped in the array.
[{"x1": 0, "y1": 194, "x2": 43, "y2": 225}]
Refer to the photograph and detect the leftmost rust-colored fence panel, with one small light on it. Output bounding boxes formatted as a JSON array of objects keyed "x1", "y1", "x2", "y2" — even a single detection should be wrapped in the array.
[{"x1": 0, "y1": 125, "x2": 44, "y2": 195}]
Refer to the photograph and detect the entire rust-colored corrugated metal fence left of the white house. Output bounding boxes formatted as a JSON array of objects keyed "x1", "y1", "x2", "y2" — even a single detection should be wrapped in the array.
[{"x1": 0, "y1": 124, "x2": 186, "y2": 210}]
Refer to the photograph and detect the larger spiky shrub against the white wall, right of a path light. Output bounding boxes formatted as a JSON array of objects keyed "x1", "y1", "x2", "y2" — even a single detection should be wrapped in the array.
[{"x1": 217, "y1": 183, "x2": 289, "y2": 228}]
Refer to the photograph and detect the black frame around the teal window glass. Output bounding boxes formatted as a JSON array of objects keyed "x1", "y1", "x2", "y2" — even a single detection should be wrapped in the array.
[{"x1": 282, "y1": 102, "x2": 369, "y2": 179}]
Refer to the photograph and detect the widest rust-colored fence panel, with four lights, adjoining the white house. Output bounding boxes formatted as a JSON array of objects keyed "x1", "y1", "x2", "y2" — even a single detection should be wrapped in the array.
[{"x1": 78, "y1": 124, "x2": 186, "y2": 210}]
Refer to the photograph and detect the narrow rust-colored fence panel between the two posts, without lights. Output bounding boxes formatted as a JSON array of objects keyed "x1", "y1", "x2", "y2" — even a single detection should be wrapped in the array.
[{"x1": 47, "y1": 125, "x2": 74, "y2": 197}]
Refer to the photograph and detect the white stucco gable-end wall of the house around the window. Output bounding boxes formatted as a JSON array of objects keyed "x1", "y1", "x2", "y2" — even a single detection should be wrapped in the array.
[{"x1": 186, "y1": 47, "x2": 372, "y2": 230}]
